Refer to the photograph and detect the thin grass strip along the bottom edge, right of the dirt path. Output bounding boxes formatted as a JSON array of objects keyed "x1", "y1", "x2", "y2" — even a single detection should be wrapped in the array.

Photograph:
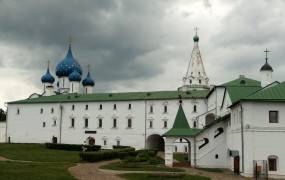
[{"x1": 119, "y1": 173, "x2": 211, "y2": 180}]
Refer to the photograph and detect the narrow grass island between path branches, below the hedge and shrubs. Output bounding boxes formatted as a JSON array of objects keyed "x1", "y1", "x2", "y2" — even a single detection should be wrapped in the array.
[{"x1": 100, "y1": 162, "x2": 185, "y2": 172}]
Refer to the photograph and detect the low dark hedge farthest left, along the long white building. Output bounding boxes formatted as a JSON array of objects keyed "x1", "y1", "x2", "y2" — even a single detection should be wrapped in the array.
[{"x1": 45, "y1": 143, "x2": 101, "y2": 151}]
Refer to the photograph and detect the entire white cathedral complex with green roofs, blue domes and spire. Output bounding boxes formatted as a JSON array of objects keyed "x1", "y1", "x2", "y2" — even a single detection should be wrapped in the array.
[{"x1": 5, "y1": 33, "x2": 285, "y2": 178}]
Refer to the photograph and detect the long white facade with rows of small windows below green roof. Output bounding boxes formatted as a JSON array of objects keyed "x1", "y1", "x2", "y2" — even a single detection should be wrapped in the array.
[{"x1": 8, "y1": 99, "x2": 206, "y2": 151}]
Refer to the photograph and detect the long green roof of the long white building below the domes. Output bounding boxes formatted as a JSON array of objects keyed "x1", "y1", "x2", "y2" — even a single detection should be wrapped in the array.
[{"x1": 8, "y1": 90, "x2": 209, "y2": 104}]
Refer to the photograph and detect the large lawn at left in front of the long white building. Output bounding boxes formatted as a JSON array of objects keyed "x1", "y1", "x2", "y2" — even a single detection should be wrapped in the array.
[{"x1": 0, "y1": 144, "x2": 80, "y2": 162}]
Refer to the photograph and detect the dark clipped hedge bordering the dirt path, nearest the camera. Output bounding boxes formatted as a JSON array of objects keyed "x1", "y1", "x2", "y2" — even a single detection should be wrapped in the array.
[{"x1": 79, "y1": 148, "x2": 137, "y2": 162}]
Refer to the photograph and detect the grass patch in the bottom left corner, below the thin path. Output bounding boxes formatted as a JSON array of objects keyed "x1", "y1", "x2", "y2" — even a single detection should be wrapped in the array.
[{"x1": 0, "y1": 161, "x2": 75, "y2": 180}]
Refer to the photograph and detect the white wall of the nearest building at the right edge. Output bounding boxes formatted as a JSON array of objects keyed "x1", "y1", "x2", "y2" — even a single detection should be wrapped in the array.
[{"x1": 227, "y1": 102, "x2": 285, "y2": 178}]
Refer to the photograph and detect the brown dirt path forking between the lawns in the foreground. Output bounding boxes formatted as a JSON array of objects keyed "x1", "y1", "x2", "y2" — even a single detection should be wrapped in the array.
[{"x1": 68, "y1": 160, "x2": 121, "y2": 180}]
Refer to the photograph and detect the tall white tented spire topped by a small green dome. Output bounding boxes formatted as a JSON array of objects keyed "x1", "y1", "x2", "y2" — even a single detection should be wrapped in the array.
[{"x1": 183, "y1": 28, "x2": 209, "y2": 89}]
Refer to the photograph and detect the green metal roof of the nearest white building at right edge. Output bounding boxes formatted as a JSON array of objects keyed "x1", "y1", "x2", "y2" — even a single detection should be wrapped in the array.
[{"x1": 242, "y1": 82, "x2": 285, "y2": 102}]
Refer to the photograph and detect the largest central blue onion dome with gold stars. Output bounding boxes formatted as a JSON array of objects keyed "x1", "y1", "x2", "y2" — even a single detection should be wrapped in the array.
[{"x1": 55, "y1": 45, "x2": 82, "y2": 77}]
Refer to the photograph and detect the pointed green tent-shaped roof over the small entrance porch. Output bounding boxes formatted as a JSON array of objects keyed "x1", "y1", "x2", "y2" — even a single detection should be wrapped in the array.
[{"x1": 163, "y1": 104, "x2": 201, "y2": 137}]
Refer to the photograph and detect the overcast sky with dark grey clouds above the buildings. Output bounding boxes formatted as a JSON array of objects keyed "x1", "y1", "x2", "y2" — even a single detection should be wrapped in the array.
[{"x1": 0, "y1": 0, "x2": 285, "y2": 107}]
